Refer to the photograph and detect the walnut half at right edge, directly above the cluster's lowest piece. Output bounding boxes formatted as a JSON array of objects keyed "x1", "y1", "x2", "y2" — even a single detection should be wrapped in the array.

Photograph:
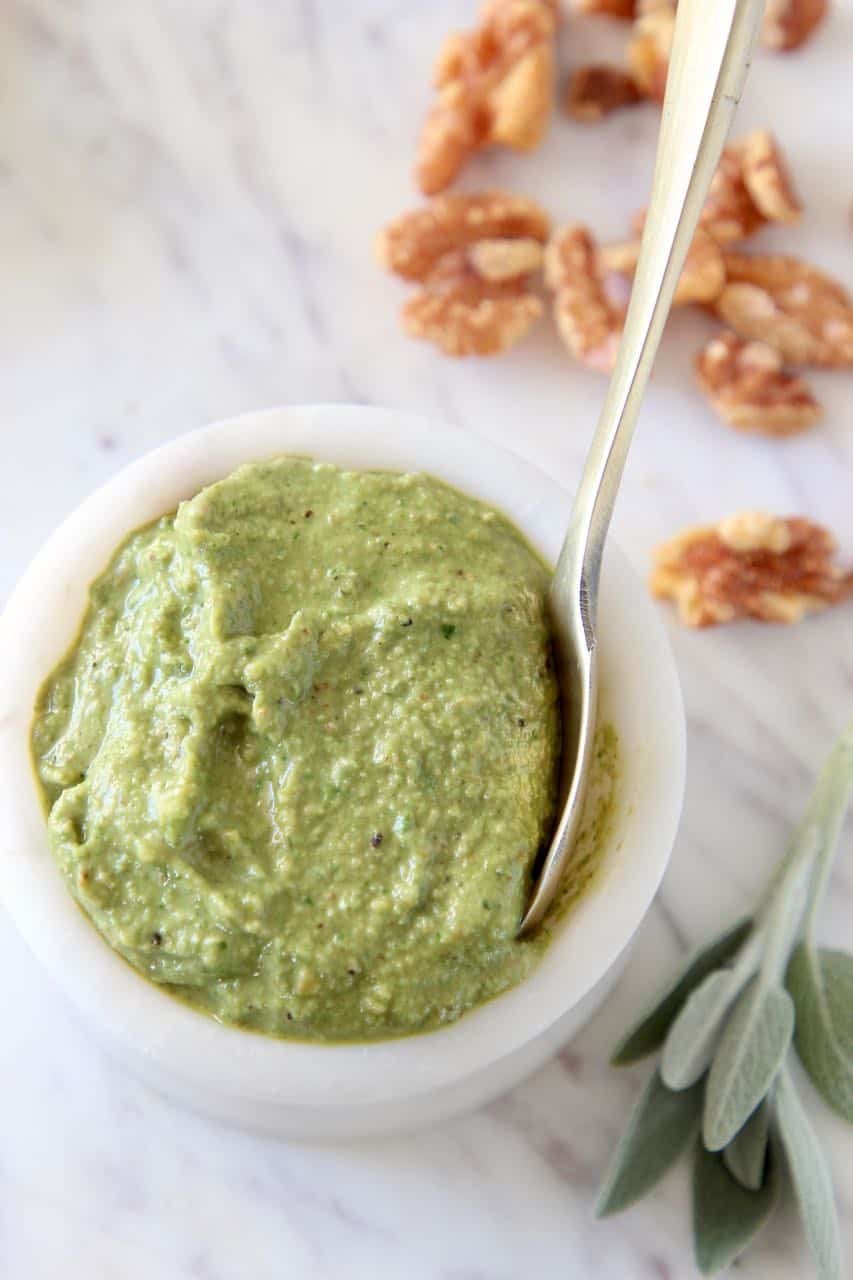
[{"x1": 715, "y1": 251, "x2": 853, "y2": 369}]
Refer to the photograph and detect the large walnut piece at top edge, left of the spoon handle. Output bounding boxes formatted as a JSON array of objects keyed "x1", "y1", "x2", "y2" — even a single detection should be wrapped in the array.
[{"x1": 415, "y1": 0, "x2": 558, "y2": 196}]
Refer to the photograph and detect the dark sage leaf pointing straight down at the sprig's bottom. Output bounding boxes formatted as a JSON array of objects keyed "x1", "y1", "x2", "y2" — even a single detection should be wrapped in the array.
[{"x1": 693, "y1": 1143, "x2": 779, "y2": 1276}]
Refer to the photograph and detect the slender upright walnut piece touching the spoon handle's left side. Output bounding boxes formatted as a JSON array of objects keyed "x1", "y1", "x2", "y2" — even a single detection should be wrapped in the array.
[{"x1": 544, "y1": 223, "x2": 628, "y2": 374}]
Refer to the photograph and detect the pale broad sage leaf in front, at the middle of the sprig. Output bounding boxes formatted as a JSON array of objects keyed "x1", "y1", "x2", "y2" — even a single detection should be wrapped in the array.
[{"x1": 702, "y1": 978, "x2": 794, "y2": 1151}]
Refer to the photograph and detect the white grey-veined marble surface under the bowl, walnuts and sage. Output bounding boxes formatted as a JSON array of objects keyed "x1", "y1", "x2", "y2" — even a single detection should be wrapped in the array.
[{"x1": 0, "y1": 0, "x2": 853, "y2": 1280}]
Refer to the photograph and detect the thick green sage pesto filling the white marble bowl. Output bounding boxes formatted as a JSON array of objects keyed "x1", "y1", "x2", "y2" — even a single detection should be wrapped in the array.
[{"x1": 32, "y1": 457, "x2": 615, "y2": 1042}]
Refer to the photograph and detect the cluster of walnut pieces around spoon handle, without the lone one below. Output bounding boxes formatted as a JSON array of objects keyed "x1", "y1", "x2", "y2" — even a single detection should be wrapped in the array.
[{"x1": 378, "y1": 0, "x2": 853, "y2": 465}]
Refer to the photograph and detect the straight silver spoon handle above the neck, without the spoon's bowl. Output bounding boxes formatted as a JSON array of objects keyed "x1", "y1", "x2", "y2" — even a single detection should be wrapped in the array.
[{"x1": 552, "y1": 0, "x2": 763, "y2": 614}]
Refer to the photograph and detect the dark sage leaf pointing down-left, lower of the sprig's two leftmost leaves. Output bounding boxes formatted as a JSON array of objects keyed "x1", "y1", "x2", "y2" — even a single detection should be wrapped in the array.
[{"x1": 596, "y1": 1071, "x2": 702, "y2": 1217}]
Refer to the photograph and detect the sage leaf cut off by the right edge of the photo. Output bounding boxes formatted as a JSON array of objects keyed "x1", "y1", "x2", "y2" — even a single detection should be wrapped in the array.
[{"x1": 786, "y1": 942, "x2": 853, "y2": 1124}]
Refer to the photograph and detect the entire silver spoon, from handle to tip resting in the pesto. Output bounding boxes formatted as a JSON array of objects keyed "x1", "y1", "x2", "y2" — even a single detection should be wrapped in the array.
[{"x1": 519, "y1": 0, "x2": 763, "y2": 934}]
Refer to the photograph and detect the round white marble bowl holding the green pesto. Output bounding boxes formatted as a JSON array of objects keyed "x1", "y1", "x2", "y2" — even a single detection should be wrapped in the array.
[{"x1": 0, "y1": 406, "x2": 685, "y2": 1138}]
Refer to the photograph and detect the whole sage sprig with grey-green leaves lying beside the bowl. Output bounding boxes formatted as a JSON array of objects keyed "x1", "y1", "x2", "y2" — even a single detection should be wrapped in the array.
[{"x1": 597, "y1": 723, "x2": 853, "y2": 1280}]
